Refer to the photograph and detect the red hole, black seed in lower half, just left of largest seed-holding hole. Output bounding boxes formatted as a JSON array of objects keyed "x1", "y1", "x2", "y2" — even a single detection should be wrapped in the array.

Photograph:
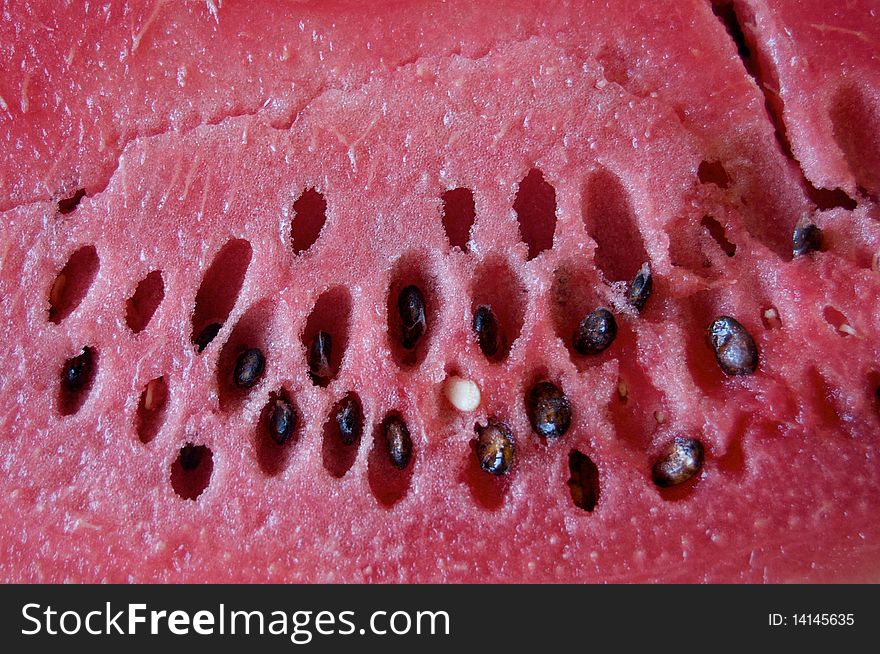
[{"x1": 302, "y1": 286, "x2": 351, "y2": 387}]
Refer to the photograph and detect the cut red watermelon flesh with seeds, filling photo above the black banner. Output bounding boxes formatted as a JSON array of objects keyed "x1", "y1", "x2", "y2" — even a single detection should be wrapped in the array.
[{"x1": 0, "y1": 0, "x2": 880, "y2": 582}]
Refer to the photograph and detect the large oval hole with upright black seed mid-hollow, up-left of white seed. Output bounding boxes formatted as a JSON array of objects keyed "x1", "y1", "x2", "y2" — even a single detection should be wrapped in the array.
[{"x1": 387, "y1": 255, "x2": 440, "y2": 368}]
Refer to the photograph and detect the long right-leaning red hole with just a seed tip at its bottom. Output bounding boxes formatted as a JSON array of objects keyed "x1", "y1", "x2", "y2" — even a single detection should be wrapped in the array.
[{"x1": 192, "y1": 239, "x2": 253, "y2": 352}]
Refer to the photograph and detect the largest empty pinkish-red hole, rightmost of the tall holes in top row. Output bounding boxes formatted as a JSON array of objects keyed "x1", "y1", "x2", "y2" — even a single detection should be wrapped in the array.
[{"x1": 581, "y1": 168, "x2": 649, "y2": 282}]
